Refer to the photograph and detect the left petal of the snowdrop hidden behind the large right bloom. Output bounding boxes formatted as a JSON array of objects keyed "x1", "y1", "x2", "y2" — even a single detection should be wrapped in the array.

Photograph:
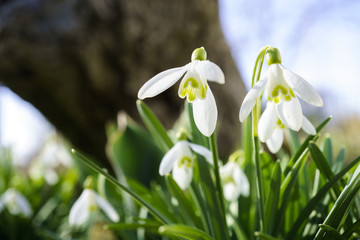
[{"x1": 258, "y1": 102, "x2": 279, "y2": 142}]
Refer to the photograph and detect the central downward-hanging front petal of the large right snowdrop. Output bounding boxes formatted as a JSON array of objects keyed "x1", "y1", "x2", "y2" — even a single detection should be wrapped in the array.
[{"x1": 275, "y1": 97, "x2": 303, "y2": 131}]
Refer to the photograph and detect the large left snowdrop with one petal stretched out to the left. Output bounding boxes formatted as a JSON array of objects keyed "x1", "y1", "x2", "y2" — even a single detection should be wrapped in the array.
[{"x1": 138, "y1": 47, "x2": 225, "y2": 137}]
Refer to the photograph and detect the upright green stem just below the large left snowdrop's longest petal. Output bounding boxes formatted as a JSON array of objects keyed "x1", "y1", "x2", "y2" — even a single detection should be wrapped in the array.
[{"x1": 209, "y1": 133, "x2": 228, "y2": 236}]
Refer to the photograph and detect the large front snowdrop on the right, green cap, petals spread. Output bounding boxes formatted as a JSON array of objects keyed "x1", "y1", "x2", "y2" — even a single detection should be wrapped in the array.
[{"x1": 239, "y1": 47, "x2": 323, "y2": 131}]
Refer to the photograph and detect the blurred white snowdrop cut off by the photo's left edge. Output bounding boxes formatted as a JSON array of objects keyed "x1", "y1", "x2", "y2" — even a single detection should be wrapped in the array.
[{"x1": 0, "y1": 188, "x2": 32, "y2": 217}]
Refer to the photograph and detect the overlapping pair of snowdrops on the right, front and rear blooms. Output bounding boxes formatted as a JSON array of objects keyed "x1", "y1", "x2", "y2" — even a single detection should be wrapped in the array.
[{"x1": 239, "y1": 47, "x2": 323, "y2": 153}]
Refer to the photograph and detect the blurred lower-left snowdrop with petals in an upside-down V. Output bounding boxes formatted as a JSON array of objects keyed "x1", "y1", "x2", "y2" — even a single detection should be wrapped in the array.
[{"x1": 69, "y1": 188, "x2": 119, "y2": 226}]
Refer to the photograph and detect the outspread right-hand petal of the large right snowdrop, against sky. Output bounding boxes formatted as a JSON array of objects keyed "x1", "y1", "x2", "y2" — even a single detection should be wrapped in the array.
[{"x1": 280, "y1": 65, "x2": 323, "y2": 107}]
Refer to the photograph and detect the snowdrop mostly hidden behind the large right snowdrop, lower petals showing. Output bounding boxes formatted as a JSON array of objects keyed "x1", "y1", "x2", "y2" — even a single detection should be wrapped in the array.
[{"x1": 258, "y1": 102, "x2": 316, "y2": 153}]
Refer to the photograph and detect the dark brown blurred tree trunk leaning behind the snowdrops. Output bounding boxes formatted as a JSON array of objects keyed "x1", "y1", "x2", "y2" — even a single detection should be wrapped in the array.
[{"x1": 0, "y1": 0, "x2": 245, "y2": 167}]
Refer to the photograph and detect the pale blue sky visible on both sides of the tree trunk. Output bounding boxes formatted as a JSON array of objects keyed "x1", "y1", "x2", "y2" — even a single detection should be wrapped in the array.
[{"x1": 0, "y1": 0, "x2": 360, "y2": 163}]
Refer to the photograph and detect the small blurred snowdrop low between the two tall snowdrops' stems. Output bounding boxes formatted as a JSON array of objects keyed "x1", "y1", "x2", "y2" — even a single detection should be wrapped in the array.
[{"x1": 220, "y1": 161, "x2": 250, "y2": 201}]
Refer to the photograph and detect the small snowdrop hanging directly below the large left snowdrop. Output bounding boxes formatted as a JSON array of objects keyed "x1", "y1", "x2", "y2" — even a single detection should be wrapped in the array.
[{"x1": 159, "y1": 141, "x2": 212, "y2": 190}]
